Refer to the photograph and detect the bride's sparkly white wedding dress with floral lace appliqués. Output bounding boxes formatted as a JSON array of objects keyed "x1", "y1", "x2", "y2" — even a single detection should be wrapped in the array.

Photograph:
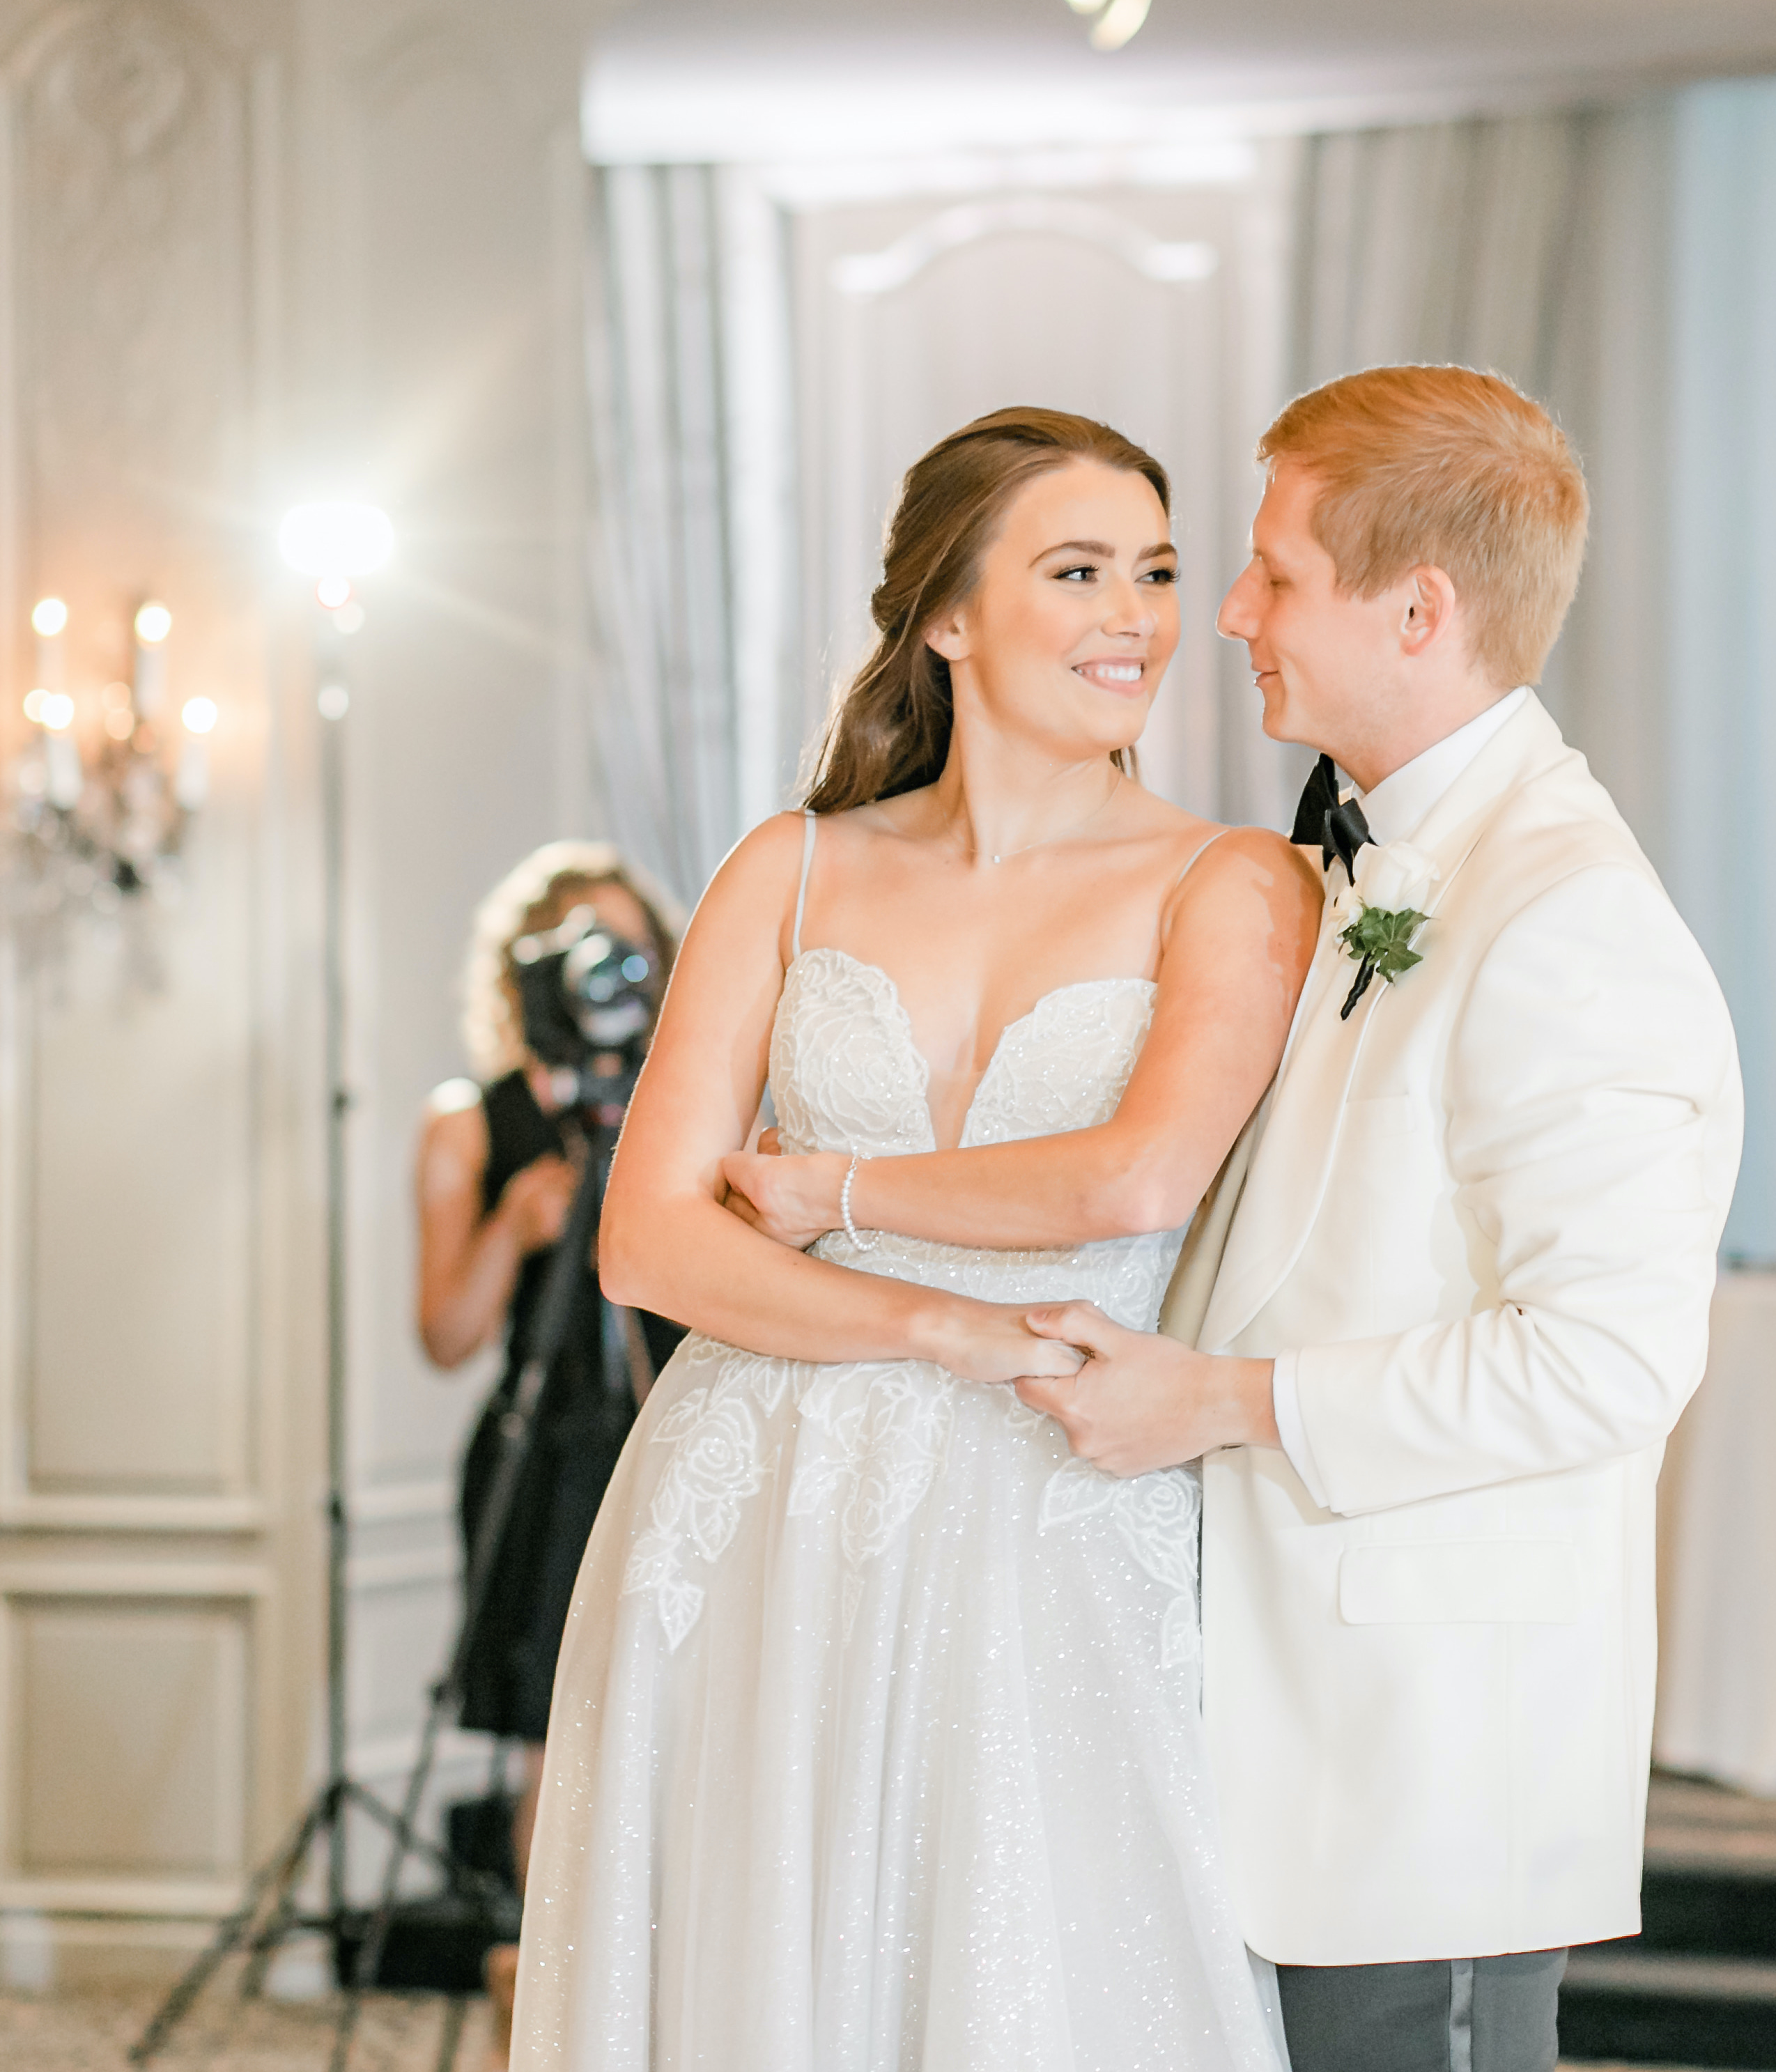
[{"x1": 512, "y1": 828, "x2": 1283, "y2": 2072}]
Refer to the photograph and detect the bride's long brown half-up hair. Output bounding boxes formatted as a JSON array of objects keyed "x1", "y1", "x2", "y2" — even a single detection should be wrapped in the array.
[{"x1": 806, "y1": 408, "x2": 1171, "y2": 812}]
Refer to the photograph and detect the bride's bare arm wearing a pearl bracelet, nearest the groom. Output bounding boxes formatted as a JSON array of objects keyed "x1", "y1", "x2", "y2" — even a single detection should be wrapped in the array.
[{"x1": 725, "y1": 829, "x2": 1320, "y2": 1247}]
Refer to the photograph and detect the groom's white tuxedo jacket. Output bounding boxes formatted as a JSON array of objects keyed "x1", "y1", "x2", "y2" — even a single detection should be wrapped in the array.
[{"x1": 1200, "y1": 696, "x2": 1740, "y2": 1964}]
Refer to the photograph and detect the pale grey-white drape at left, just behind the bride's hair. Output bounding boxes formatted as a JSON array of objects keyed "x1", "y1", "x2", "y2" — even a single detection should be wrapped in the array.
[{"x1": 587, "y1": 166, "x2": 796, "y2": 902}]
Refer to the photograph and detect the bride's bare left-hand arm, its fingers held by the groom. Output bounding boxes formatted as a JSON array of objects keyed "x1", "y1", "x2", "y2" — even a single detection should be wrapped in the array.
[{"x1": 599, "y1": 814, "x2": 1078, "y2": 1380}]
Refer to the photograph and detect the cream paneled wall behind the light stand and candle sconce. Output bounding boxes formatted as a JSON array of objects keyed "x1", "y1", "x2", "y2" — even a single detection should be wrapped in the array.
[{"x1": 0, "y1": 0, "x2": 597, "y2": 1983}]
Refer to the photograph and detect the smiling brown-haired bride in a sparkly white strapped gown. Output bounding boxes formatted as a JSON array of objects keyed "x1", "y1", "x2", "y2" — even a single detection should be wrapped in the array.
[{"x1": 514, "y1": 410, "x2": 1318, "y2": 2072}]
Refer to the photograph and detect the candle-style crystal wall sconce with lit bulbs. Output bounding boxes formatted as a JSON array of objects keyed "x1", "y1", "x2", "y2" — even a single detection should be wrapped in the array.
[{"x1": 10, "y1": 597, "x2": 219, "y2": 914}]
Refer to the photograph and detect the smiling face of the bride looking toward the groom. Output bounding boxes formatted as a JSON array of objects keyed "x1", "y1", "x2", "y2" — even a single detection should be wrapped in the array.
[{"x1": 927, "y1": 460, "x2": 1177, "y2": 757}]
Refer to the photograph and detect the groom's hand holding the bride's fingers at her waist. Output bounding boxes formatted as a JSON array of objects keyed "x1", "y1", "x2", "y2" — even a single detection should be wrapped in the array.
[{"x1": 1017, "y1": 1301, "x2": 1281, "y2": 1475}]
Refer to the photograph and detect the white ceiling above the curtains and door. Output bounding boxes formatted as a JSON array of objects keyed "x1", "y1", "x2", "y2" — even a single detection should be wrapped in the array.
[{"x1": 587, "y1": 0, "x2": 1776, "y2": 157}]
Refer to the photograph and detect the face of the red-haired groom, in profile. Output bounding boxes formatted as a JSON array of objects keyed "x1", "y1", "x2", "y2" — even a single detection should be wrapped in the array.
[{"x1": 1214, "y1": 460, "x2": 1399, "y2": 768}]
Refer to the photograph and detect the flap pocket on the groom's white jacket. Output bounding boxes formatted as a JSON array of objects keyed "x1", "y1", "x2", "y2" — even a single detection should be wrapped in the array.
[{"x1": 1338, "y1": 1540, "x2": 1579, "y2": 1627}]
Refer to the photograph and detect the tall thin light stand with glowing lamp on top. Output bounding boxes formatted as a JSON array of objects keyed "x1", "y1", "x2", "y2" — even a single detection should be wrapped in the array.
[{"x1": 128, "y1": 504, "x2": 462, "y2": 2072}]
